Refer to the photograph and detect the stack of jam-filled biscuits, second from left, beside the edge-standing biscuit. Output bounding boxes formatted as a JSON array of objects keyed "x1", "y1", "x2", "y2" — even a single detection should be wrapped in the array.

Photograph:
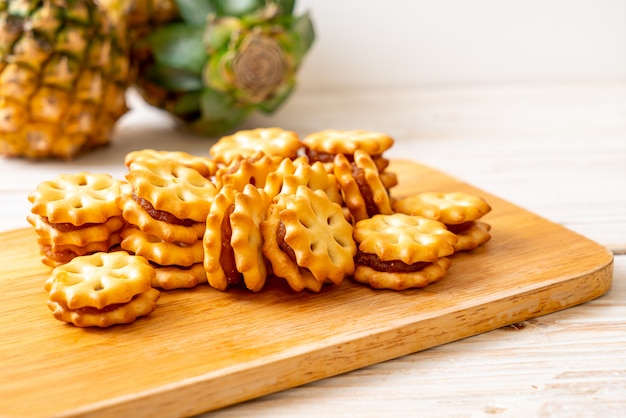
[{"x1": 118, "y1": 150, "x2": 217, "y2": 290}]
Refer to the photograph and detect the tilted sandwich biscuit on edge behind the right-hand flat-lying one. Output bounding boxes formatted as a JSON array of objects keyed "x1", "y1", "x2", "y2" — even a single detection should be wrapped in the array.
[{"x1": 334, "y1": 150, "x2": 392, "y2": 221}]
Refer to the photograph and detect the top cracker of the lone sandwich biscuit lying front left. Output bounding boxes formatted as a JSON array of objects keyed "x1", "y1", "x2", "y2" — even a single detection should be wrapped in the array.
[{"x1": 45, "y1": 251, "x2": 156, "y2": 310}]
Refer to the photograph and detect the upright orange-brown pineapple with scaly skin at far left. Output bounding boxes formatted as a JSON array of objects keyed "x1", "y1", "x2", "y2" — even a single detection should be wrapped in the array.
[{"x1": 0, "y1": 0, "x2": 130, "y2": 159}]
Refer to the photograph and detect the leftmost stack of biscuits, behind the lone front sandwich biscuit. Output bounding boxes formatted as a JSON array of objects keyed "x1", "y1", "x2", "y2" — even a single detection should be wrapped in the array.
[{"x1": 27, "y1": 172, "x2": 125, "y2": 267}]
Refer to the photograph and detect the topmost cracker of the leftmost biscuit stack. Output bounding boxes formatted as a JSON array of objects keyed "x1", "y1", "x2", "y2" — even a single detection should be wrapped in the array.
[{"x1": 28, "y1": 172, "x2": 122, "y2": 226}]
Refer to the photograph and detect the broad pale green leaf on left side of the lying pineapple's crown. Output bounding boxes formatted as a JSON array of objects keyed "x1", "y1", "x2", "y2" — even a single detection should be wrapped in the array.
[{"x1": 149, "y1": 23, "x2": 207, "y2": 75}]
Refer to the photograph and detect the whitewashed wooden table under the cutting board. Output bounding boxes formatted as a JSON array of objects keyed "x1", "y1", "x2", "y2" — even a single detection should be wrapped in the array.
[{"x1": 0, "y1": 83, "x2": 626, "y2": 417}]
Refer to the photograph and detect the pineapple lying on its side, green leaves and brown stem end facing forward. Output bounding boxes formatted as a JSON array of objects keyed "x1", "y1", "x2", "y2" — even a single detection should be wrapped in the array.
[{"x1": 130, "y1": 0, "x2": 315, "y2": 137}]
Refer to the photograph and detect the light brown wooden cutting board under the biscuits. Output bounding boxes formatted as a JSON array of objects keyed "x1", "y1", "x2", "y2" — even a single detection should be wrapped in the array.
[{"x1": 0, "y1": 162, "x2": 613, "y2": 417}]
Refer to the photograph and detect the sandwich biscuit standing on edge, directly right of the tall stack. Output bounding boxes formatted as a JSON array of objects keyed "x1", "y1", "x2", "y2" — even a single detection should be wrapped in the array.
[{"x1": 203, "y1": 184, "x2": 269, "y2": 292}]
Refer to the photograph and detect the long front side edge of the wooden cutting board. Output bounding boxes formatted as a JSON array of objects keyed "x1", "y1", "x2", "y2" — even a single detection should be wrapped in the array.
[{"x1": 60, "y1": 254, "x2": 613, "y2": 418}]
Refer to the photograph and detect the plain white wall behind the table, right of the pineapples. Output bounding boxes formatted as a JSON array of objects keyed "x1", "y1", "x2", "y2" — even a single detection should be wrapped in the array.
[{"x1": 297, "y1": 0, "x2": 626, "y2": 88}]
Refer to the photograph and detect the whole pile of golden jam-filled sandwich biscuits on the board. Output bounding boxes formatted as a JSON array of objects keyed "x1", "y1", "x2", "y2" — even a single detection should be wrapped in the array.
[{"x1": 29, "y1": 128, "x2": 491, "y2": 326}]
